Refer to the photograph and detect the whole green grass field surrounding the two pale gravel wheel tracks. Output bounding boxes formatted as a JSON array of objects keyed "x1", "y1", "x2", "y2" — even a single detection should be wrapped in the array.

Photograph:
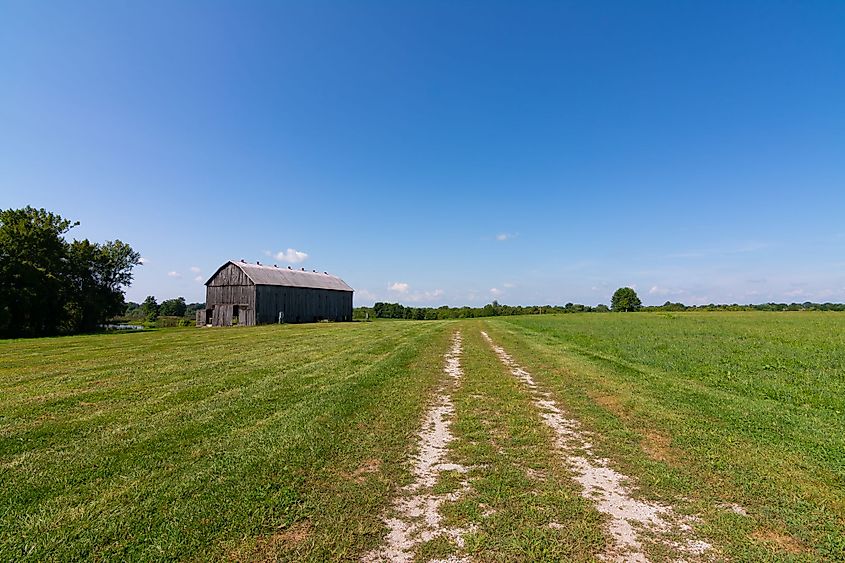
[{"x1": 0, "y1": 313, "x2": 845, "y2": 561}]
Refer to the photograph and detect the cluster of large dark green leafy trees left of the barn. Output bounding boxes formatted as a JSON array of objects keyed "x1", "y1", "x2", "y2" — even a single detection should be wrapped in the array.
[{"x1": 0, "y1": 206, "x2": 141, "y2": 337}]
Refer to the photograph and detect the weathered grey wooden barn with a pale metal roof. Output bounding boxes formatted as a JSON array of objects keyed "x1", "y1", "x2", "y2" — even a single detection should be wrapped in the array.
[{"x1": 197, "y1": 260, "x2": 353, "y2": 326}]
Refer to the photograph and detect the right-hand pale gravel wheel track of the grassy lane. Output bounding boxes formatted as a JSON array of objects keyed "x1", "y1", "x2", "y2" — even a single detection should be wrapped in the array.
[{"x1": 481, "y1": 332, "x2": 711, "y2": 562}]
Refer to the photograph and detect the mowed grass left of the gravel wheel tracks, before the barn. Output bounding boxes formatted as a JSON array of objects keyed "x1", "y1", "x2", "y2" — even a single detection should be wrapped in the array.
[{"x1": 0, "y1": 323, "x2": 450, "y2": 561}]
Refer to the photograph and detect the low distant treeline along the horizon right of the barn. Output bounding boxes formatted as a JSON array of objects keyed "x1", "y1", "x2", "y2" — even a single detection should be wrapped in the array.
[{"x1": 353, "y1": 301, "x2": 845, "y2": 320}]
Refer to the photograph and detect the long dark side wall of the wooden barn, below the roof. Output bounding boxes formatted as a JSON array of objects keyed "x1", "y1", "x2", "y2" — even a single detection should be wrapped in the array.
[{"x1": 256, "y1": 285, "x2": 352, "y2": 324}]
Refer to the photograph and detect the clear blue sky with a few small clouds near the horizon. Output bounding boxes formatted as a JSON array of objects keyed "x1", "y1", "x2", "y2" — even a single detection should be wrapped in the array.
[{"x1": 0, "y1": 0, "x2": 845, "y2": 305}]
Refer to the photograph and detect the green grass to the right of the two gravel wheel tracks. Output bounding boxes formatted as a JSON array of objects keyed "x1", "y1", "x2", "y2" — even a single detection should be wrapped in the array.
[{"x1": 485, "y1": 312, "x2": 845, "y2": 561}]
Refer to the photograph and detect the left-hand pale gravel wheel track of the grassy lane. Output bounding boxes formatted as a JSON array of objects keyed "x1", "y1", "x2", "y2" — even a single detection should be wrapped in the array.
[{"x1": 363, "y1": 332, "x2": 470, "y2": 563}]
